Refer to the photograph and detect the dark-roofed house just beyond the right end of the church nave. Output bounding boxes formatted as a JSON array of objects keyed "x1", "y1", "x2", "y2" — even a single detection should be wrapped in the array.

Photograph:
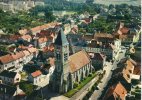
[{"x1": 88, "y1": 52, "x2": 106, "y2": 70}]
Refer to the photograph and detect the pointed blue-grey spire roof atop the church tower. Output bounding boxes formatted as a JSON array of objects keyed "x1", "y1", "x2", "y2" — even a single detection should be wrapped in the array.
[{"x1": 55, "y1": 29, "x2": 68, "y2": 46}]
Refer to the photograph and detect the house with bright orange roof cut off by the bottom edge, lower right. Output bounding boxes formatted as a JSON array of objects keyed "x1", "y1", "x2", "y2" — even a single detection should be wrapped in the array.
[{"x1": 103, "y1": 82, "x2": 127, "y2": 100}]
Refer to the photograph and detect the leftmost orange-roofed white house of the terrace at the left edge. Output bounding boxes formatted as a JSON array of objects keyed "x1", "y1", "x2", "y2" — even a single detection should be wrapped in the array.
[{"x1": 0, "y1": 54, "x2": 15, "y2": 72}]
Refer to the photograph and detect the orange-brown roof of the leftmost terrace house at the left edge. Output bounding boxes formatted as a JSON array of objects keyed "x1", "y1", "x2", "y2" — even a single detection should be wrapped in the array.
[{"x1": 0, "y1": 54, "x2": 14, "y2": 64}]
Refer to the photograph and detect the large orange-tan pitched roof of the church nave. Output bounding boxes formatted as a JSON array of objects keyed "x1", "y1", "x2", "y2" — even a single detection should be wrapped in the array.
[{"x1": 69, "y1": 51, "x2": 91, "y2": 73}]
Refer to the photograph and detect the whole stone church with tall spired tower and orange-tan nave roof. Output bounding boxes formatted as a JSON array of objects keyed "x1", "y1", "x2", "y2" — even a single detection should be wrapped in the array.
[{"x1": 51, "y1": 29, "x2": 93, "y2": 93}]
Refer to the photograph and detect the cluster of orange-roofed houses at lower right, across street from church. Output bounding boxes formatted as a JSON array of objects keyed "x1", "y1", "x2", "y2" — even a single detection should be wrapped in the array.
[{"x1": 103, "y1": 58, "x2": 141, "y2": 100}]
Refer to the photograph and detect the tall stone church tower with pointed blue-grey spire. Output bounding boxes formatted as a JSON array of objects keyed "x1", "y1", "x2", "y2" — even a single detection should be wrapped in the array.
[{"x1": 53, "y1": 29, "x2": 70, "y2": 93}]
